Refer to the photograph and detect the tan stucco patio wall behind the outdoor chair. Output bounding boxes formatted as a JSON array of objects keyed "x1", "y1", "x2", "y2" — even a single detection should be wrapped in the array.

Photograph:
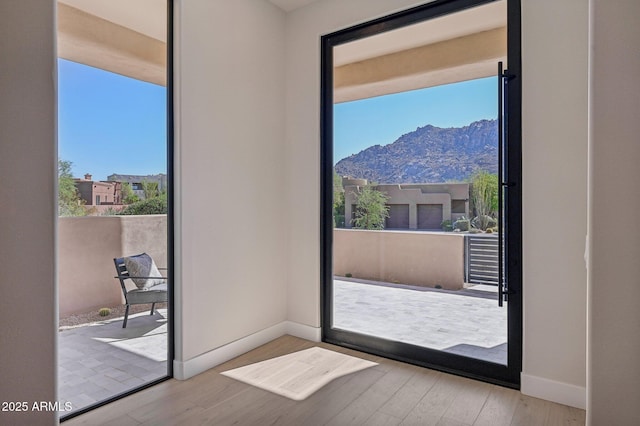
[{"x1": 58, "y1": 215, "x2": 167, "y2": 315}]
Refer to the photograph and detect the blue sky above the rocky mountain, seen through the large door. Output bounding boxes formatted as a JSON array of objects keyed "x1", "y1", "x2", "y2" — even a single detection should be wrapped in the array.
[{"x1": 333, "y1": 77, "x2": 498, "y2": 164}]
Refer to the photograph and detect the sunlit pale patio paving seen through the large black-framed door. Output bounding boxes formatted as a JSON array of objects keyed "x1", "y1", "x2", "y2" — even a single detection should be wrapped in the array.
[{"x1": 333, "y1": 279, "x2": 507, "y2": 364}]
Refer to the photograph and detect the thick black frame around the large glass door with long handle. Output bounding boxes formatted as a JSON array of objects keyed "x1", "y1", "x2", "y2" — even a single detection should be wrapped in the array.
[{"x1": 320, "y1": 0, "x2": 522, "y2": 389}]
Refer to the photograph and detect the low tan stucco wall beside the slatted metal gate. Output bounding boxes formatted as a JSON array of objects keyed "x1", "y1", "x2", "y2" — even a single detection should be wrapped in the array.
[{"x1": 333, "y1": 229, "x2": 464, "y2": 290}]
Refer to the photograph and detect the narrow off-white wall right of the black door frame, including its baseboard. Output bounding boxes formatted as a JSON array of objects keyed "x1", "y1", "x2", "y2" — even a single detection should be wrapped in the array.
[{"x1": 522, "y1": 0, "x2": 589, "y2": 407}]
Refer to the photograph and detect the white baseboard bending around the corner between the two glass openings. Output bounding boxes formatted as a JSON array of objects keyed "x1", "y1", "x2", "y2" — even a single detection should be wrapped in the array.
[{"x1": 173, "y1": 321, "x2": 321, "y2": 380}]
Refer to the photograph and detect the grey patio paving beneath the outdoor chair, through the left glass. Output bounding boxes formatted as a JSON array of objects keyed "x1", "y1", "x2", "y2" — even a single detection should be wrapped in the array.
[{"x1": 58, "y1": 309, "x2": 167, "y2": 410}]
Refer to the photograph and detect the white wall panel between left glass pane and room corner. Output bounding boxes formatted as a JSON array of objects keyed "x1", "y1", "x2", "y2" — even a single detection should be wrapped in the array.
[{"x1": 175, "y1": 0, "x2": 287, "y2": 368}]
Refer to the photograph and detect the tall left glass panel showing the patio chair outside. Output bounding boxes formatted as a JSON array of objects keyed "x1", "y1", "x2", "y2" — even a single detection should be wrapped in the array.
[{"x1": 57, "y1": 0, "x2": 173, "y2": 421}]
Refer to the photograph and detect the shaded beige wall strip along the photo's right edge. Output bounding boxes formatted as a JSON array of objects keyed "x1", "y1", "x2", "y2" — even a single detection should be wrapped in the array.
[{"x1": 587, "y1": 0, "x2": 640, "y2": 426}]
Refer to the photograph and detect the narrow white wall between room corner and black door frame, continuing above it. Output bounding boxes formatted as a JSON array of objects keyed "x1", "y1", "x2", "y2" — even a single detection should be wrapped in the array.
[{"x1": 286, "y1": 0, "x2": 424, "y2": 327}]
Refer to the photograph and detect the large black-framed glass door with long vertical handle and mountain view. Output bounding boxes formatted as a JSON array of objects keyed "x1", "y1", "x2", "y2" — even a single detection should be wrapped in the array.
[{"x1": 322, "y1": 1, "x2": 521, "y2": 387}]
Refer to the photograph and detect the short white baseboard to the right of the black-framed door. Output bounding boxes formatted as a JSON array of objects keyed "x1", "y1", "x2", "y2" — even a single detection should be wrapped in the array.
[{"x1": 520, "y1": 373, "x2": 587, "y2": 410}]
